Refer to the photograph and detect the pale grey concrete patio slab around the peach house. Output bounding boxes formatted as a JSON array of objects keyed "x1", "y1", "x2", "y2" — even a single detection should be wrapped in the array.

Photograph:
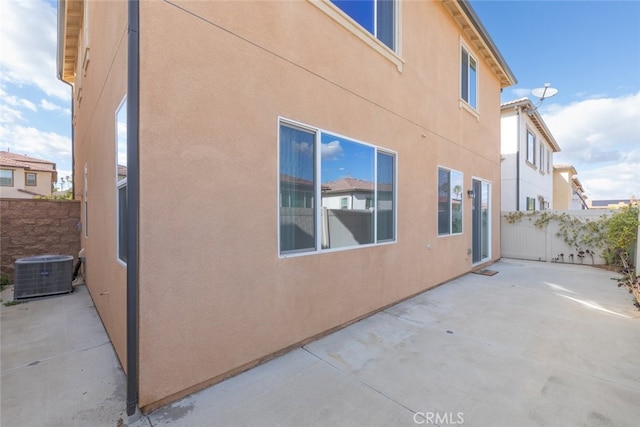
[{"x1": 1, "y1": 260, "x2": 640, "y2": 427}]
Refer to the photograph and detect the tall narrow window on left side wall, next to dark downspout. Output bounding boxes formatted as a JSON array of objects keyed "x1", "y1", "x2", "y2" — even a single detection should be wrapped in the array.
[{"x1": 115, "y1": 97, "x2": 128, "y2": 264}]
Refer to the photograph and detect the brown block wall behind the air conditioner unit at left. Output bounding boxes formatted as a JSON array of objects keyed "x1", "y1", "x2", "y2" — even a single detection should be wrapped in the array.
[{"x1": 0, "y1": 199, "x2": 80, "y2": 282}]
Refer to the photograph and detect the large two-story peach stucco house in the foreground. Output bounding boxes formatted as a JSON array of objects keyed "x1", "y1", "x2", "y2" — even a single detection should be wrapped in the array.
[{"x1": 58, "y1": 0, "x2": 515, "y2": 413}]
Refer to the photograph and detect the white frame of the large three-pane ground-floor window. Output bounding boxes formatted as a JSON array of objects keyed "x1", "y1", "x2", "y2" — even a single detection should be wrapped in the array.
[{"x1": 276, "y1": 117, "x2": 398, "y2": 258}]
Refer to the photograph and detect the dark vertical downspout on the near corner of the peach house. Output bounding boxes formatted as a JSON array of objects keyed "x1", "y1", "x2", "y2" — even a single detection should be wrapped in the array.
[{"x1": 127, "y1": 0, "x2": 140, "y2": 416}]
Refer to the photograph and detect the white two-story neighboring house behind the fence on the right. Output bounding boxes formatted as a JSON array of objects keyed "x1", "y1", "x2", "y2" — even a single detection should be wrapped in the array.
[{"x1": 500, "y1": 98, "x2": 560, "y2": 211}]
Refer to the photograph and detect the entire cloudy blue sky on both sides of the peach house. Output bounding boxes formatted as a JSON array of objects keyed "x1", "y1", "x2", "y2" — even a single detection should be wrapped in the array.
[{"x1": 0, "y1": 0, "x2": 640, "y2": 199}]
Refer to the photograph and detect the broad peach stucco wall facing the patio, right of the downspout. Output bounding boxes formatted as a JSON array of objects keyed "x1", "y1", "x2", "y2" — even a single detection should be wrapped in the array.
[{"x1": 135, "y1": 1, "x2": 500, "y2": 409}]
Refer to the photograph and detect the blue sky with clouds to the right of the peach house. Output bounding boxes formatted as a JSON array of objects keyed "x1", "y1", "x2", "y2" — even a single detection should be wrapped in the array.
[{"x1": 471, "y1": 0, "x2": 640, "y2": 200}]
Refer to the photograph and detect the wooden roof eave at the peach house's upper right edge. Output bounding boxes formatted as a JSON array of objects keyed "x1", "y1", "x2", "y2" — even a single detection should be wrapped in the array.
[{"x1": 442, "y1": 0, "x2": 518, "y2": 88}]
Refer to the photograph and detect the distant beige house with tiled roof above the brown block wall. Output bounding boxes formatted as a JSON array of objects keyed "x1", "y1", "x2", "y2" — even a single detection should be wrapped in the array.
[{"x1": 0, "y1": 151, "x2": 58, "y2": 199}]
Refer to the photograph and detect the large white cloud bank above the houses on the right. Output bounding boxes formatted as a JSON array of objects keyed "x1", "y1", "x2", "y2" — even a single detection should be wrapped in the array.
[{"x1": 543, "y1": 92, "x2": 640, "y2": 200}]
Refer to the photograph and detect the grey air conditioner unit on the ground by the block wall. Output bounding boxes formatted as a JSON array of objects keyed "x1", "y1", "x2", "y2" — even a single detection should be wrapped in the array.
[{"x1": 13, "y1": 255, "x2": 73, "y2": 300}]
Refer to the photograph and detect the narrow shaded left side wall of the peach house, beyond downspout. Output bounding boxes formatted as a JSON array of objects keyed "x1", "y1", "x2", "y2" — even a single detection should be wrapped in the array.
[{"x1": 74, "y1": 2, "x2": 127, "y2": 369}]
